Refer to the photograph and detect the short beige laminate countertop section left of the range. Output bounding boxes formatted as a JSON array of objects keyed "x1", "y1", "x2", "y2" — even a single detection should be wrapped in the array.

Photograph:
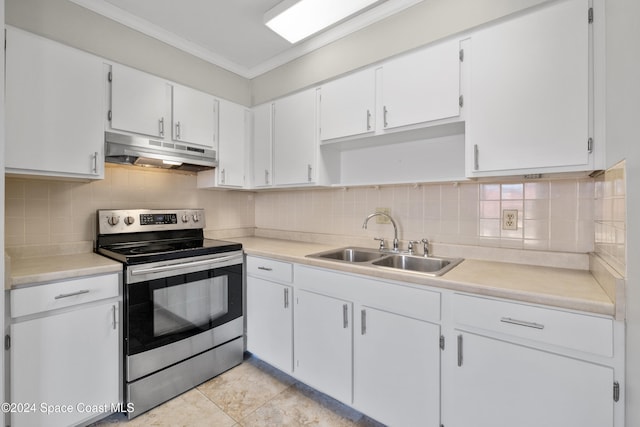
[{"x1": 5, "y1": 252, "x2": 122, "y2": 289}]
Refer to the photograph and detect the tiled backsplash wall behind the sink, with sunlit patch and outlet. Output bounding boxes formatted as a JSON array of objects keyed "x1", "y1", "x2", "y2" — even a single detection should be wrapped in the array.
[{"x1": 256, "y1": 178, "x2": 594, "y2": 253}]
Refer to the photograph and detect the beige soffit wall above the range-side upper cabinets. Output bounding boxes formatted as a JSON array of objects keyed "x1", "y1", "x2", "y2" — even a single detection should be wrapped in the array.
[{"x1": 6, "y1": 0, "x2": 251, "y2": 106}]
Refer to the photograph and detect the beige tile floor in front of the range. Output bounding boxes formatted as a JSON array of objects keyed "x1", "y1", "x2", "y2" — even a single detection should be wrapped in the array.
[{"x1": 93, "y1": 357, "x2": 383, "y2": 427}]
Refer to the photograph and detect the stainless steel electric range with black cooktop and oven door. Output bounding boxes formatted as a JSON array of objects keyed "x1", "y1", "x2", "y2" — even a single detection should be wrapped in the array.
[{"x1": 96, "y1": 209, "x2": 244, "y2": 418}]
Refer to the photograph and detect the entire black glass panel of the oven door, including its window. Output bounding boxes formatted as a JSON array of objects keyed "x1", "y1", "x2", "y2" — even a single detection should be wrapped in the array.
[{"x1": 125, "y1": 264, "x2": 242, "y2": 356}]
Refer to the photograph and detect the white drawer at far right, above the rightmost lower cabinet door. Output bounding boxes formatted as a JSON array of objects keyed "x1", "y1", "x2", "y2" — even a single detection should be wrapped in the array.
[{"x1": 453, "y1": 294, "x2": 613, "y2": 357}]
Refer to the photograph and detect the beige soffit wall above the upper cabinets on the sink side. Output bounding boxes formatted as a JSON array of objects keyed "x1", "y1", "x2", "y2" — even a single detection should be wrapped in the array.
[{"x1": 252, "y1": 0, "x2": 548, "y2": 105}]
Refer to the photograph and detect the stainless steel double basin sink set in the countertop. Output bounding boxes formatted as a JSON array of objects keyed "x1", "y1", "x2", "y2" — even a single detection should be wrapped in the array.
[{"x1": 307, "y1": 247, "x2": 463, "y2": 276}]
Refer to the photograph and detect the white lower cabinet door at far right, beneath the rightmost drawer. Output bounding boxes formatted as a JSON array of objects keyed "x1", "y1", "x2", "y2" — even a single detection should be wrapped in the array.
[{"x1": 450, "y1": 332, "x2": 614, "y2": 427}]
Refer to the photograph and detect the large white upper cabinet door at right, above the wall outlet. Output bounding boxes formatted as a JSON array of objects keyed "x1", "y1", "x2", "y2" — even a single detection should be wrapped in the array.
[{"x1": 466, "y1": 0, "x2": 589, "y2": 175}]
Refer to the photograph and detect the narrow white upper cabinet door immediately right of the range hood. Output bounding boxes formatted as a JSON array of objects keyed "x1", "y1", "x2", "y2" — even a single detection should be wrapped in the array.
[{"x1": 218, "y1": 100, "x2": 247, "y2": 187}]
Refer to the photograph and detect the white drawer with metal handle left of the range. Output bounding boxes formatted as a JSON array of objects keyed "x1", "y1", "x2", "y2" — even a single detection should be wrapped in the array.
[{"x1": 11, "y1": 274, "x2": 119, "y2": 317}]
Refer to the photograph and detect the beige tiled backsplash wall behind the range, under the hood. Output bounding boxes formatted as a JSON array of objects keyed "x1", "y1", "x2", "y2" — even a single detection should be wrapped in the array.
[{"x1": 5, "y1": 165, "x2": 255, "y2": 250}]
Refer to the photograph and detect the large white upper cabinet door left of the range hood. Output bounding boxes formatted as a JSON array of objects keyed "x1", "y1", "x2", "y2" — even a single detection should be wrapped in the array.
[{"x1": 5, "y1": 28, "x2": 104, "y2": 178}]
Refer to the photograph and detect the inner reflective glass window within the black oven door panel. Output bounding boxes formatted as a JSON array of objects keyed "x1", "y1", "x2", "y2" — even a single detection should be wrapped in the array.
[{"x1": 152, "y1": 276, "x2": 228, "y2": 337}]
